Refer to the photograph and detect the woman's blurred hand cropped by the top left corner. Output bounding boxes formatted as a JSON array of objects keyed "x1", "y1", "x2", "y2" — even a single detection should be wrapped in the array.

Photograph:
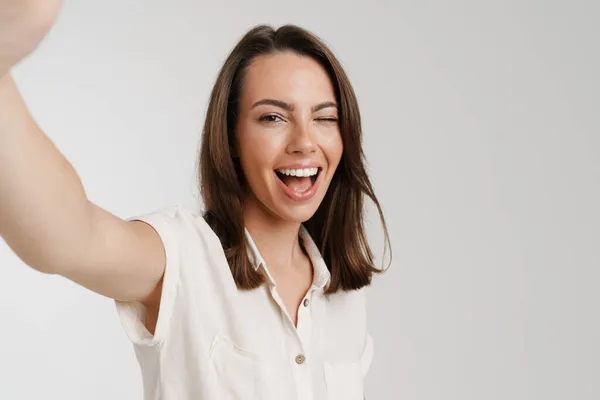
[{"x1": 0, "y1": 0, "x2": 61, "y2": 77}]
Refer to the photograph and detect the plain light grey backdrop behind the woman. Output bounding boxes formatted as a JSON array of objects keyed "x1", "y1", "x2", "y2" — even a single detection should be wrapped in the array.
[{"x1": 0, "y1": 0, "x2": 600, "y2": 400}]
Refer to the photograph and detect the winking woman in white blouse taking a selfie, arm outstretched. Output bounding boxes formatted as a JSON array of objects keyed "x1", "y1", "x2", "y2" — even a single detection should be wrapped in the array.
[{"x1": 0, "y1": 0, "x2": 389, "y2": 400}]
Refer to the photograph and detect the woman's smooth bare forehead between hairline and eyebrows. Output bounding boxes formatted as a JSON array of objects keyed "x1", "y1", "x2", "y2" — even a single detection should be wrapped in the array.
[{"x1": 241, "y1": 51, "x2": 335, "y2": 103}]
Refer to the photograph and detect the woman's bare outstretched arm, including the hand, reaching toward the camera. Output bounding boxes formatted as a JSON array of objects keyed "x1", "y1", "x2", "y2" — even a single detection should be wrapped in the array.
[{"x1": 0, "y1": 0, "x2": 165, "y2": 305}]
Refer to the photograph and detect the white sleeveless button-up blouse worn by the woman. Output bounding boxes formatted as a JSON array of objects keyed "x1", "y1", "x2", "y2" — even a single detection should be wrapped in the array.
[{"x1": 116, "y1": 206, "x2": 373, "y2": 400}]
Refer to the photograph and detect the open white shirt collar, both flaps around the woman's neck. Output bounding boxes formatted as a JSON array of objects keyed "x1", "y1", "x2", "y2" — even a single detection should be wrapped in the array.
[{"x1": 244, "y1": 225, "x2": 331, "y2": 289}]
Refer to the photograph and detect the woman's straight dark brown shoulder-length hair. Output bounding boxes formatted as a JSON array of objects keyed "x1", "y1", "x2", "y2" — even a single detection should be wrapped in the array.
[{"x1": 198, "y1": 25, "x2": 391, "y2": 293}]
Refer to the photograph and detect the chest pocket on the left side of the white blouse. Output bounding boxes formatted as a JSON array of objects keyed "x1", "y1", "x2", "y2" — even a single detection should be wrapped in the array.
[{"x1": 209, "y1": 335, "x2": 286, "y2": 400}]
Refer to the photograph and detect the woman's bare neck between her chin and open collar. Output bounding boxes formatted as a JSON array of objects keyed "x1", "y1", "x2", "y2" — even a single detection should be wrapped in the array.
[{"x1": 244, "y1": 195, "x2": 302, "y2": 270}]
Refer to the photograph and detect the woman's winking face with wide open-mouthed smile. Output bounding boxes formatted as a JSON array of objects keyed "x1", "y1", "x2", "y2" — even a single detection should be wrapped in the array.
[{"x1": 236, "y1": 52, "x2": 343, "y2": 222}]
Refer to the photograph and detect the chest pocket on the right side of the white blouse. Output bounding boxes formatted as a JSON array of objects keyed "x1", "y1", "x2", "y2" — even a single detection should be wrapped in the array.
[{"x1": 323, "y1": 335, "x2": 373, "y2": 400}]
